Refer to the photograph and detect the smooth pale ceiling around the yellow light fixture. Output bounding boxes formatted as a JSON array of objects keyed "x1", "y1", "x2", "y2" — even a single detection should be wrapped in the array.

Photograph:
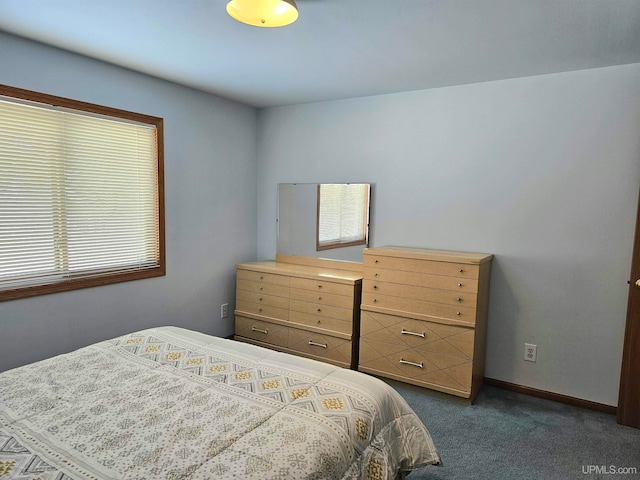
[{"x1": 0, "y1": 0, "x2": 640, "y2": 107}]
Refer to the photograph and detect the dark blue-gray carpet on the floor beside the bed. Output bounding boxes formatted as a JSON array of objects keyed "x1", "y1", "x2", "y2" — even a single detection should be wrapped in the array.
[{"x1": 388, "y1": 381, "x2": 640, "y2": 480}]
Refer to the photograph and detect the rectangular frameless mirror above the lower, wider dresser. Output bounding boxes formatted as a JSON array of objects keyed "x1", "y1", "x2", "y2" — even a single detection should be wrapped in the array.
[{"x1": 276, "y1": 183, "x2": 371, "y2": 262}]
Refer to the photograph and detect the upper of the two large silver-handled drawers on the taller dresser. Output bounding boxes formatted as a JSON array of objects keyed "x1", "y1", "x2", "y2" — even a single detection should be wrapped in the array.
[{"x1": 360, "y1": 311, "x2": 475, "y2": 361}]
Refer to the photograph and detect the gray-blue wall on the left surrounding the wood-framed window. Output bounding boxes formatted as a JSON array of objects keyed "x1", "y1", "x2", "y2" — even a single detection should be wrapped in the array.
[{"x1": 0, "y1": 33, "x2": 257, "y2": 371}]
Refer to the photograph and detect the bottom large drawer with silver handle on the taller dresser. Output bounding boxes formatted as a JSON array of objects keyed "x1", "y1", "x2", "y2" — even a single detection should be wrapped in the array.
[{"x1": 358, "y1": 337, "x2": 473, "y2": 397}]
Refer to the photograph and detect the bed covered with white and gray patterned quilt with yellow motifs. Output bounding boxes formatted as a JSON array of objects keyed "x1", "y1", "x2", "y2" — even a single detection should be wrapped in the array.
[{"x1": 0, "y1": 327, "x2": 440, "y2": 480}]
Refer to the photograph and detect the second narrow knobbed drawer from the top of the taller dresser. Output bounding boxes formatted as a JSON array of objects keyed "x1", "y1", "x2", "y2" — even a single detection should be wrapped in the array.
[{"x1": 364, "y1": 267, "x2": 478, "y2": 293}]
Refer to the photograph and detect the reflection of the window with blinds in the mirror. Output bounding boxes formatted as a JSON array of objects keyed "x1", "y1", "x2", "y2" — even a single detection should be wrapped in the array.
[{"x1": 316, "y1": 183, "x2": 369, "y2": 250}]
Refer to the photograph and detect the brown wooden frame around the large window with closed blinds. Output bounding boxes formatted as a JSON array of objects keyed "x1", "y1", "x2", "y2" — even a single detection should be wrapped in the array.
[{"x1": 0, "y1": 85, "x2": 166, "y2": 301}]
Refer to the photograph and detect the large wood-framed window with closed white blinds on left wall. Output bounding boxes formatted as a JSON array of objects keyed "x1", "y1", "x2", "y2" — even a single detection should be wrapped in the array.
[{"x1": 0, "y1": 85, "x2": 165, "y2": 300}]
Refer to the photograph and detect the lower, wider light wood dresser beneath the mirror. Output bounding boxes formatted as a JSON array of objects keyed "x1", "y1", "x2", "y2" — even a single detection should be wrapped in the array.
[{"x1": 234, "y1": 255, "x2": 362, "y2": 369}]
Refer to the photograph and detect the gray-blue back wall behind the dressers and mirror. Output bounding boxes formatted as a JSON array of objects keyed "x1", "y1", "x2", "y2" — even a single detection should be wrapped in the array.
[{"x1": 258, "y1": 64, "x2": 640, "y2": 405}]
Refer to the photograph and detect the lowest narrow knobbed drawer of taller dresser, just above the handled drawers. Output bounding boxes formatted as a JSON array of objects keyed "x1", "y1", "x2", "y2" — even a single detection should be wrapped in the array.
[{"x1": 362, "y1": 292, "x2": 476, "y2": 325}]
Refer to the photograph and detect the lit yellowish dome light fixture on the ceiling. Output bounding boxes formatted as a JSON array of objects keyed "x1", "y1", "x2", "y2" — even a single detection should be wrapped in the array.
[{"x1": 227, "y1": 0, "x2": 298, "y2": 27}]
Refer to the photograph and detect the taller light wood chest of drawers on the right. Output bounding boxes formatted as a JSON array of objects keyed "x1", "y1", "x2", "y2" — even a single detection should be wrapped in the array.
[{"x1": 358, "y1": 246, "x2": 493, "y2": 401}]
